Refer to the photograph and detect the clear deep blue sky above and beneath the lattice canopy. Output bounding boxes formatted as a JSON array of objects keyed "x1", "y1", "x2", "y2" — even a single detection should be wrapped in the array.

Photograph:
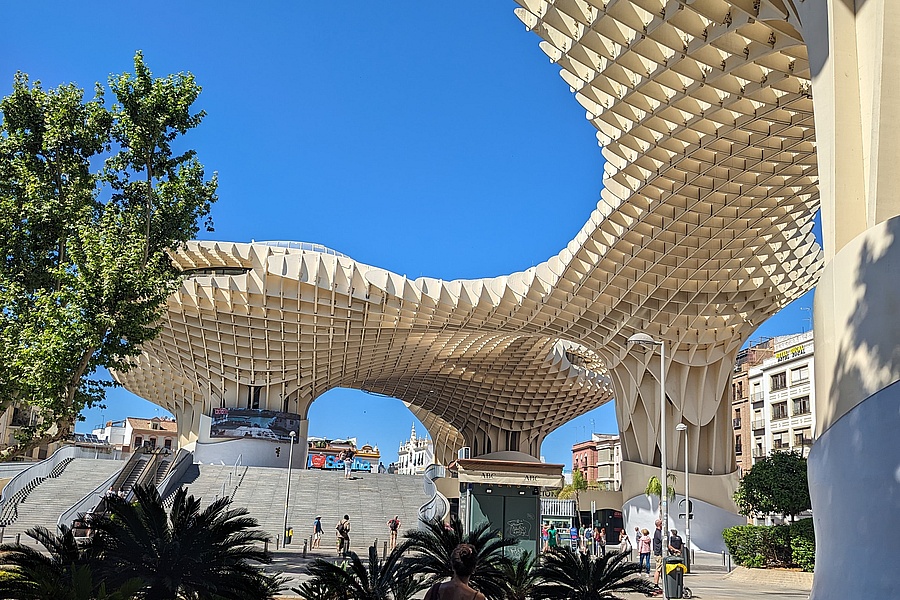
[{"x1": 0, "y1": 0, "x2": 812, "y2": 465}]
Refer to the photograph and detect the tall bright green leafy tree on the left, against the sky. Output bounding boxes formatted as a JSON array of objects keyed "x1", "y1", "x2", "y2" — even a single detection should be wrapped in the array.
[{"x1": 0, "y1": 52, "x2": 217, "y2": 460}]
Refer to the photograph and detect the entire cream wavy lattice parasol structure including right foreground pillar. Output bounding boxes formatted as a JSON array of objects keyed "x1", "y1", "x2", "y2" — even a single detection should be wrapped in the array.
[{"x1": 117, "y1": 0, "x2": 900, "y2": 598}]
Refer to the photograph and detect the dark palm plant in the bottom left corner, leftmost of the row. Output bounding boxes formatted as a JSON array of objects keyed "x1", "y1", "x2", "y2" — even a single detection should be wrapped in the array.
[{"x1": 0, "y1": 525, "x2": 143, "y2": 600}]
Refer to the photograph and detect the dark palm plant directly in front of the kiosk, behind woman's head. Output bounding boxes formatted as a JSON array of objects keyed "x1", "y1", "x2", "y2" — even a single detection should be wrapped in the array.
[{"x1": 397, "y1": 517, "x2": 516, "y2": 600}]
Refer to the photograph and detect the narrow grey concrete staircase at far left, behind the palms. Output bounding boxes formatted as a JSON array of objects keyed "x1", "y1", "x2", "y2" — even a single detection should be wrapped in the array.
[{"x1": 3, "y1": 458, "x2": 125, "y2": 544}]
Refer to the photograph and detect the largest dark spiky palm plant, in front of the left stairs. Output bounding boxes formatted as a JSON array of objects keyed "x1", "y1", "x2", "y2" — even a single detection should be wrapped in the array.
[{"x1": 88, "y1": 486, "x2": 283, "y2": 600}]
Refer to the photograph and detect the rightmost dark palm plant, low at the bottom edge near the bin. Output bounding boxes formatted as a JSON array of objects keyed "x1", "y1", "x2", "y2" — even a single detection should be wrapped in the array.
[{"x1": 533, "y1": 548, "x2": 654, "y2": 600}]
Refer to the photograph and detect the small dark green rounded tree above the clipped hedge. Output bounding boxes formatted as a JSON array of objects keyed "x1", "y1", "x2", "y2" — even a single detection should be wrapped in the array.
[{"x1": 734, "y1": 451, "x2": 812, "y2": 521}]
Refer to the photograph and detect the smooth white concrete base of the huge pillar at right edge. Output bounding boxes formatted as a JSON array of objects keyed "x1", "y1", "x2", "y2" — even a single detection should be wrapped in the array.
[{"x1": 809, "y1": 217, "x2": 900, "y2": 600}]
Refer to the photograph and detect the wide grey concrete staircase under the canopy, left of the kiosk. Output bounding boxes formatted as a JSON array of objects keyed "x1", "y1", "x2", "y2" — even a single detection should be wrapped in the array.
[{"x1": 185, "y1": 465, "x2": 428, "y2": 551}]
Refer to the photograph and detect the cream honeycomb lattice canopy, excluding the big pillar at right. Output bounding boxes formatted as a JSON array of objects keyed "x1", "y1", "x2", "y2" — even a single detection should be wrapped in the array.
[{"x1": 116, "y1": 0, "x2": 821, "y2": 473}]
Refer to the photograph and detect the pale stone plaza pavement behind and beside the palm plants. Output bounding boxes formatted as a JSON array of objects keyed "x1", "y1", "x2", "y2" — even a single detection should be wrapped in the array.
[{"x1": 271, "y1": 547, "x2": 812, "y2": 600}]
